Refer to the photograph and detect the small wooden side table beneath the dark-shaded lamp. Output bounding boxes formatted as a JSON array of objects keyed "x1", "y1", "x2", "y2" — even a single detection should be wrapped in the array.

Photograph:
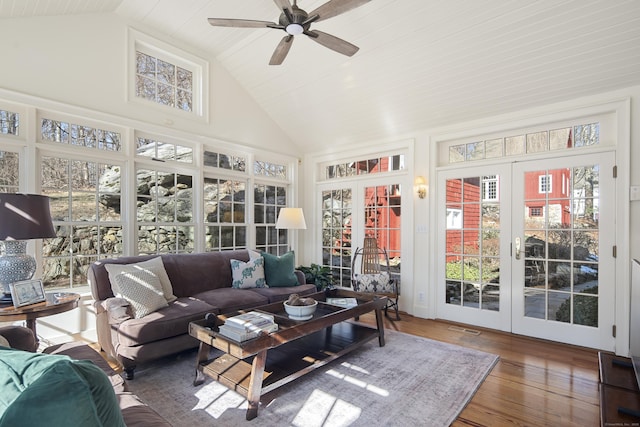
[{"x1": 0, "y1": 292, "x2": 80, "y2": 340}]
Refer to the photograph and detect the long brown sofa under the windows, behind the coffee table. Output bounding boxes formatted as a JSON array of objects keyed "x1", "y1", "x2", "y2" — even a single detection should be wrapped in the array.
[{"x1": 88, "y1": 250, "x2": 316, "y2": 379}]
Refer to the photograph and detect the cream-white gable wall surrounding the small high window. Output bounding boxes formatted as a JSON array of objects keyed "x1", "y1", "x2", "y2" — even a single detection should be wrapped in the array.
[{"x1": 0, "y1": 14, "x2": 299, "y2": 155}]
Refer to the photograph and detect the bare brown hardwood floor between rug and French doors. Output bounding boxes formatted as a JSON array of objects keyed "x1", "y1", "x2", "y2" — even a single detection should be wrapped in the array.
[{"x1": 360, "y1": 314, "x2": 600, "y2": 427}]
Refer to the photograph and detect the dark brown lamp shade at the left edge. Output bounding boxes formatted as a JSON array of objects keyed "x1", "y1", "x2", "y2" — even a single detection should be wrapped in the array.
[{"x1": 0, "y1": 193, "x2": 56, "y2": 240}]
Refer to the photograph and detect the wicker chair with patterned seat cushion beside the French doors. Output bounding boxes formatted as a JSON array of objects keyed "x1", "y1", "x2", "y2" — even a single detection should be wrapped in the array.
[{"x1": 351, "y1": 237, "x2": 400, "y2": 320}]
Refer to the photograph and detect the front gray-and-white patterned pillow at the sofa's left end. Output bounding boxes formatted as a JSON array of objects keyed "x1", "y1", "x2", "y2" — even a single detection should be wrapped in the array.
[{"x1": 115, "y1": 270, "x2": 168, "y2": 319}]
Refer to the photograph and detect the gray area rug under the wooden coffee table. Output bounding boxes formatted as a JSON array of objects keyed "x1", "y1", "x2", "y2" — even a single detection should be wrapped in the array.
[{"x1": 129, "y1": 331, "x2": 498, "y2": 427}]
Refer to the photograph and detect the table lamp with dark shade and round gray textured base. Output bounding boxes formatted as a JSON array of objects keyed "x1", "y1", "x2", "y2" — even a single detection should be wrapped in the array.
[{"x1": 0, "y1": 193, "x2": 56, "y2": 304}]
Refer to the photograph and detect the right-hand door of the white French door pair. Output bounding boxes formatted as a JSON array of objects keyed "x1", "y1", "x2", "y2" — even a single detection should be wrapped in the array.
[{"x1": 512, "y1": 153, "x2": 615, "y2": 350}]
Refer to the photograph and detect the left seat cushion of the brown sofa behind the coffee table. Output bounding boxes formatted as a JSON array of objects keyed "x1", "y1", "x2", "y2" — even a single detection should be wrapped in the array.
[{"x1": 117, "y1": 298, "x2": 215, "y2": 346}]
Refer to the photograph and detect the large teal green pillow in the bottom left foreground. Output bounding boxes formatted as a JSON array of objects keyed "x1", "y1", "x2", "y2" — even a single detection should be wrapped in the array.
[{"x1": 0, "y1": 348, "x2": 125, "y2": 427}]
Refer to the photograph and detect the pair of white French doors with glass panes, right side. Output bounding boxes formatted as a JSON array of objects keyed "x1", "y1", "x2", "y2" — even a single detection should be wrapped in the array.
[{"x1": 437, "y1": 153, "x2": 615, "y2": 350}]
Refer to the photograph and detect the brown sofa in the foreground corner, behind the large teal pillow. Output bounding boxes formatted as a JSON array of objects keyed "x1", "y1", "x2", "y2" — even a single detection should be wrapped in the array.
[{"x1": 0, "y1": 326, "x2": 171, "y2": 427}]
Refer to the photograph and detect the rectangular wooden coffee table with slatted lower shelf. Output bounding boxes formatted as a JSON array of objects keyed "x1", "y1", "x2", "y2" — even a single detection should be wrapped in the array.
[{"x1": 189, "y1": 291, "x2": 387, "y2": 420}]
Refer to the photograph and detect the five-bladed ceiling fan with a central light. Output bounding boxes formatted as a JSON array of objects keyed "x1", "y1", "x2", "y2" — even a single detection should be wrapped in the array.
[{"x1": 209, "y1": 0, "x2": 371, "y2": 65}]
